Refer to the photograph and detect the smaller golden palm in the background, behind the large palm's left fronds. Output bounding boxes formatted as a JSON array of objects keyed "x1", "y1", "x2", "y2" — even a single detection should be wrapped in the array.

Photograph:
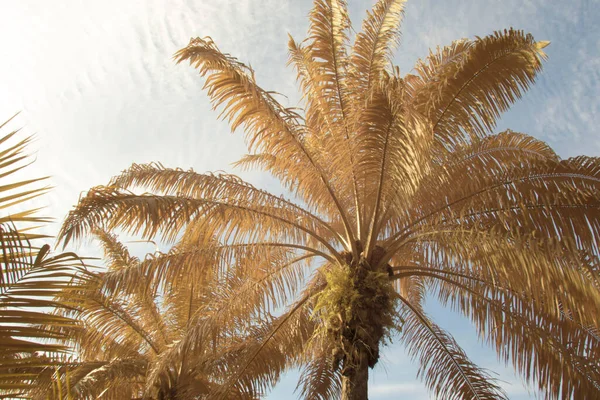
[{"x1": 46, "y1": 229, "x2": 276, "y2": 400}]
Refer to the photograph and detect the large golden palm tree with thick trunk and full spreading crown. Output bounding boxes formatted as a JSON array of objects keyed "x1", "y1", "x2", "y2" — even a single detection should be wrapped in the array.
[{"x1": 61, "y1": 0, "x2": 600, "y2": 399}]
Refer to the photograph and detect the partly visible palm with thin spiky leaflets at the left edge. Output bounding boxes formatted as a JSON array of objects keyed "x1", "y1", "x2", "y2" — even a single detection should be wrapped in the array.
[{"x1": 0, "y1": 116, "x2": 81, "y2": 398}]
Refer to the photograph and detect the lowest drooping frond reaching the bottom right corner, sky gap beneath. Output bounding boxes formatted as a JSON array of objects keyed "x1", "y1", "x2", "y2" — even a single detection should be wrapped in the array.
[{"x1": 428, "y1": 277, "x2": 600, "y2": 399}]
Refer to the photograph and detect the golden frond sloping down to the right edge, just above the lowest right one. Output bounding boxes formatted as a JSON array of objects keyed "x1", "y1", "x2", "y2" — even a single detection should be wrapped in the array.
[{"x1": 399, "y1": 231, "x2": 600, "y2": 325}]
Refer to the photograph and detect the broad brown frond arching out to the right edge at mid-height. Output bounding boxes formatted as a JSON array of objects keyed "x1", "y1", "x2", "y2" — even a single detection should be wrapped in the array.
[{"x1": 388, "y1": 147, "x2": 598, "y2": 262}]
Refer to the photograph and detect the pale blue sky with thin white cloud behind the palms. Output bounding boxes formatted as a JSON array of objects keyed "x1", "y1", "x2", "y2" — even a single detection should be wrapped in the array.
[{"x1": 0, "y1": 0, "x2": 600, "y2": 400}]
